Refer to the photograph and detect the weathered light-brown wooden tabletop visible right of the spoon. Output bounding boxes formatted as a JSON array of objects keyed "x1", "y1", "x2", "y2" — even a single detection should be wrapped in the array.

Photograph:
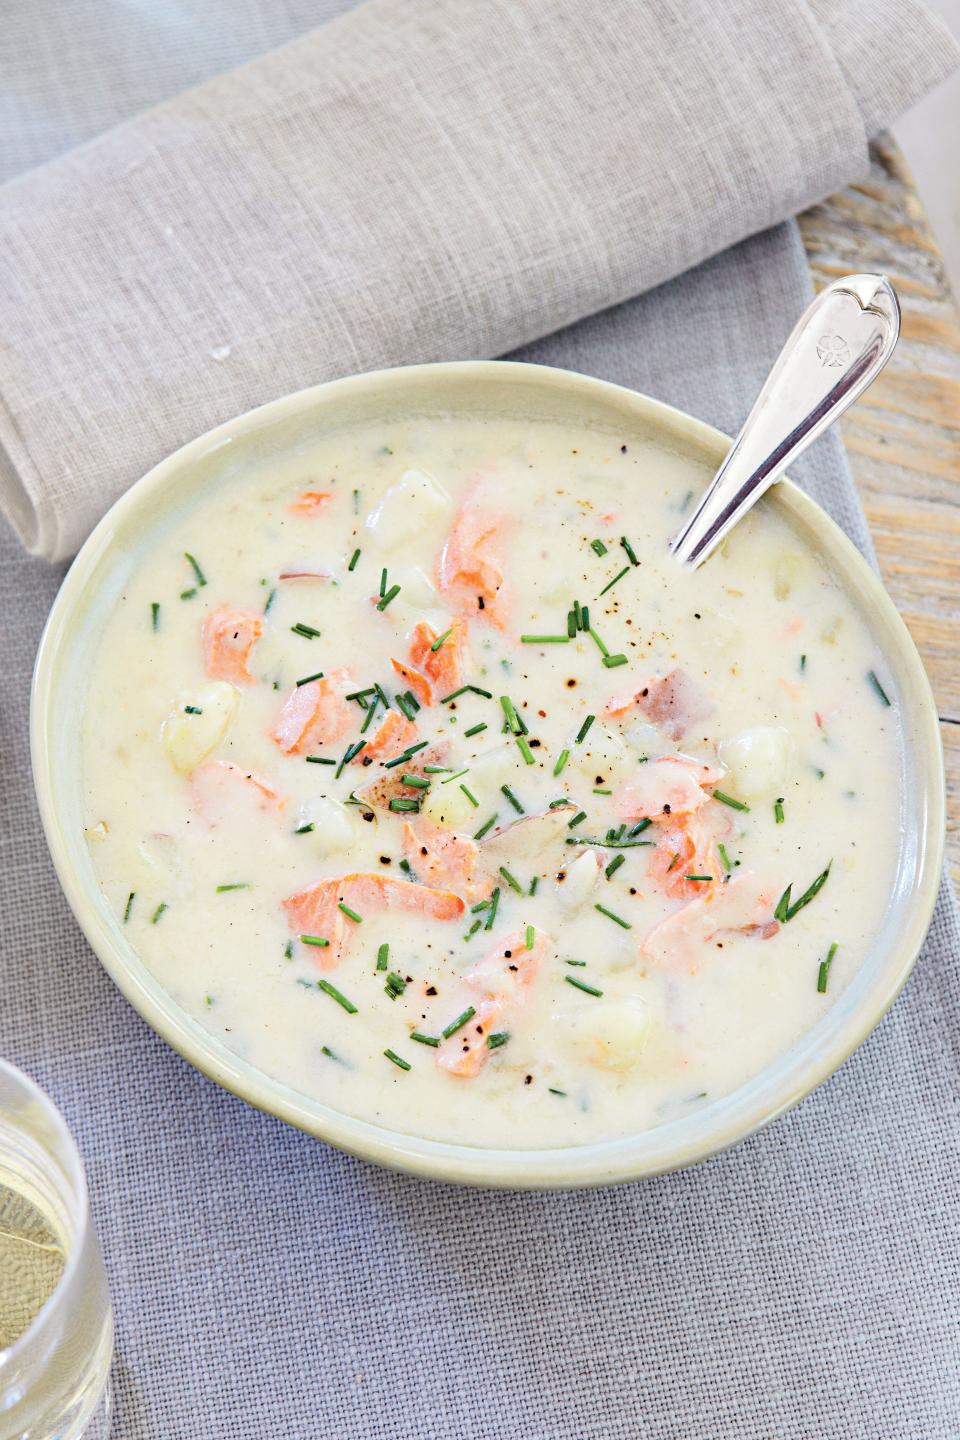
[{"x1": 800, "y1": 140, "x2": 960, "y2": 887}]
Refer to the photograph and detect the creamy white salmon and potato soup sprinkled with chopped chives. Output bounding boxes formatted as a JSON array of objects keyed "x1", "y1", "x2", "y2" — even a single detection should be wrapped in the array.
[{"x1": 83, "y1": 416, "x2": 901, "y2": 1146}]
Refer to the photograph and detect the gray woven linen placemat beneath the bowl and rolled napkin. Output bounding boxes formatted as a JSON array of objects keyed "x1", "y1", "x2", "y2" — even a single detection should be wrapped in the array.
[{"x1": 0, "y1": 0, "x2": 960, "y2": 1440}]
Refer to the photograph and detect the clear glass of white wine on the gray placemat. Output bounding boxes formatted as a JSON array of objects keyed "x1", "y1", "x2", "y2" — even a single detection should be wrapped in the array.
[{"x1": 0, "y1": 1061, "x2": 114, "y2": 1440}]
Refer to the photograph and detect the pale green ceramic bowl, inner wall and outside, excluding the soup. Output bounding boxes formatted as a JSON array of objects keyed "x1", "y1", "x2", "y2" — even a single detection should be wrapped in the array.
[{"x1": 32, "y1": 361, "x2": 944, "y2": 1188}]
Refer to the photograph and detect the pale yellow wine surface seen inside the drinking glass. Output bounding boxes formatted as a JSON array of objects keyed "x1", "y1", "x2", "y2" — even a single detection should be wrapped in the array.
[{"x1": 0, "y1": 1171, "x2": 66, "y2": 1351}]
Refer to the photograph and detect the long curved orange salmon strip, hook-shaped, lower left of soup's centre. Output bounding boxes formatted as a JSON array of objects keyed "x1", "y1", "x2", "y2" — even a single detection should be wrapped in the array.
[{"x1": 284, "y1": 871, "x2": 466, "y2": 971}]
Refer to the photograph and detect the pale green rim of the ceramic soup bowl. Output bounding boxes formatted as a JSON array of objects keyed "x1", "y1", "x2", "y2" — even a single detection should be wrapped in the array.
[{"x1": 30, "y1": 360, "x2": 944, "y2": 1189}]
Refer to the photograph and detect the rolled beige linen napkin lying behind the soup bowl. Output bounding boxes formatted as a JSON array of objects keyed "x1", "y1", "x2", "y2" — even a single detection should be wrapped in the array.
[{"x1": 0, "y1": 0, "x2": 957, "y2": 559}]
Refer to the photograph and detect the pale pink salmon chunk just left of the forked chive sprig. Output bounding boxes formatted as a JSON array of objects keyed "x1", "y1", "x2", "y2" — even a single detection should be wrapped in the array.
[{"x1": 640, "y1": 870, "x2": 780, "y2": 975}]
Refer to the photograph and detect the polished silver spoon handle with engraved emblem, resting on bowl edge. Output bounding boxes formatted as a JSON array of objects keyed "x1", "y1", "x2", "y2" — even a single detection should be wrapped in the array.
[{"x1": 671, "y1": 275, "x2": 900, "y2": 569}]
